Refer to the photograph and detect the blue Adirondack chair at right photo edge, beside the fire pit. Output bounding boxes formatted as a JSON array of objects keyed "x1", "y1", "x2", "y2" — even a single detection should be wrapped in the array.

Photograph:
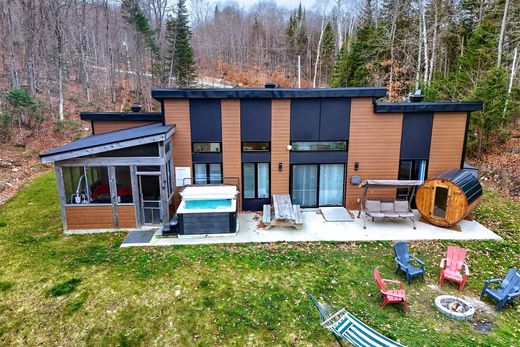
[{"x1": 480, "y1": 269, "x2": 520, "y2": 312}]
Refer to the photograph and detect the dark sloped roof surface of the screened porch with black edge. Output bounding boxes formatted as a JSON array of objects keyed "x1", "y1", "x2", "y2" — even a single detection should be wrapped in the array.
[{"x1": 40, "y1": 124, "x2": 175, "y2": 159}]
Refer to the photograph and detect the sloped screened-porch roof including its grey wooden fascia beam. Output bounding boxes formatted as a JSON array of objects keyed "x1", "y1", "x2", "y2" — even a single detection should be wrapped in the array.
[{"x1": 40, "y1": 123, "x2": 175, "y2": 163}]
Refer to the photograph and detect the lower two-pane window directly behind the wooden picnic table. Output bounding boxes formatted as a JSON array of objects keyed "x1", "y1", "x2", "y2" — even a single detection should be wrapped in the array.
[{"x1": 243, "y1": 163, "x2": 269, "y2": 199}]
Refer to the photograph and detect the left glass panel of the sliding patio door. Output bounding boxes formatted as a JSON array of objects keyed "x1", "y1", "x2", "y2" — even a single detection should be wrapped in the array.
[{"x1": 292, "y1": 165, "x2": 318, "y2": 206}]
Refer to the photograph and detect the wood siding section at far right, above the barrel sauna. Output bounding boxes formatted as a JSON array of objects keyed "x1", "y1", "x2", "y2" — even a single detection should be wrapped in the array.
[{"x1": 428, "y1": 112, "x2": 467, "y2": 177}]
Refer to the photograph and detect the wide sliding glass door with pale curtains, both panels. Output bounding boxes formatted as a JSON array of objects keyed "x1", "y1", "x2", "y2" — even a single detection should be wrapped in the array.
[{"x1": 291, "y1": 164, "x2": 345, "y2": 207}]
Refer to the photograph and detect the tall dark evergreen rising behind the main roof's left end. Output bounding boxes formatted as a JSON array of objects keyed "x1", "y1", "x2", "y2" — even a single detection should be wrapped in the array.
[{"x1": 168, "y1": 0, "x2": 196, "y2": 88}]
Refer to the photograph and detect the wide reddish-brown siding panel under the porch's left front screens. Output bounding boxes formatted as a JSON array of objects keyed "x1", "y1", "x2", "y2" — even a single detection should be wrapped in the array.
[{"x1": 65, "y1": 205, "x2": 114, "y2": 230}]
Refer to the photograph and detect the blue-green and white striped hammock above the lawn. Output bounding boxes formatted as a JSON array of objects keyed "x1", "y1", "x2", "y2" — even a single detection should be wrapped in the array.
[{"x1": 307, "y1": 293, "x2": 403, "y2": 347}]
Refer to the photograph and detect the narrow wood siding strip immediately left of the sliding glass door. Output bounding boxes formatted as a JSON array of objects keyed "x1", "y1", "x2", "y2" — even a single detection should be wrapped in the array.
[{"x1": 271, "y1": 99, "x2": 291, "y2": 194}]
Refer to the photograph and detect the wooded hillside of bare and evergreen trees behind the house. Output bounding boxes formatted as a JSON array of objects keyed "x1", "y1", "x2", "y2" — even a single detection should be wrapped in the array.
[{"x1": 0, "y1": 0, "x2": 520, "y2": 157}]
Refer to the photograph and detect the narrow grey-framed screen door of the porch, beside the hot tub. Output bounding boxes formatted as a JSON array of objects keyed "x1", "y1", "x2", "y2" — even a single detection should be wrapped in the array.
[{"x1": 138, "y1": 175, "x2": 162, "y2": 225}]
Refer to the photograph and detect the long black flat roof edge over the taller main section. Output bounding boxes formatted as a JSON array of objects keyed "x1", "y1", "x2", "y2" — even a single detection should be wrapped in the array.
[{"x1": 152, "y1": 87, "x2": 386, "y2": 100}]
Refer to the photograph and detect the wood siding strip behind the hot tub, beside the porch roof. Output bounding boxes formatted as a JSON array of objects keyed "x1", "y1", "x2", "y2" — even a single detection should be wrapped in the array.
[{"x1": 164, "y1": 99, "x2": 193, "y2": 206}]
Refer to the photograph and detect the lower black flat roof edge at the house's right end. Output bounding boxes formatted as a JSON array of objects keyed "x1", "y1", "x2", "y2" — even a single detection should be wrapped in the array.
[{"x1": 375, "y1": 101, "x2": 484, "y2": 113}]
